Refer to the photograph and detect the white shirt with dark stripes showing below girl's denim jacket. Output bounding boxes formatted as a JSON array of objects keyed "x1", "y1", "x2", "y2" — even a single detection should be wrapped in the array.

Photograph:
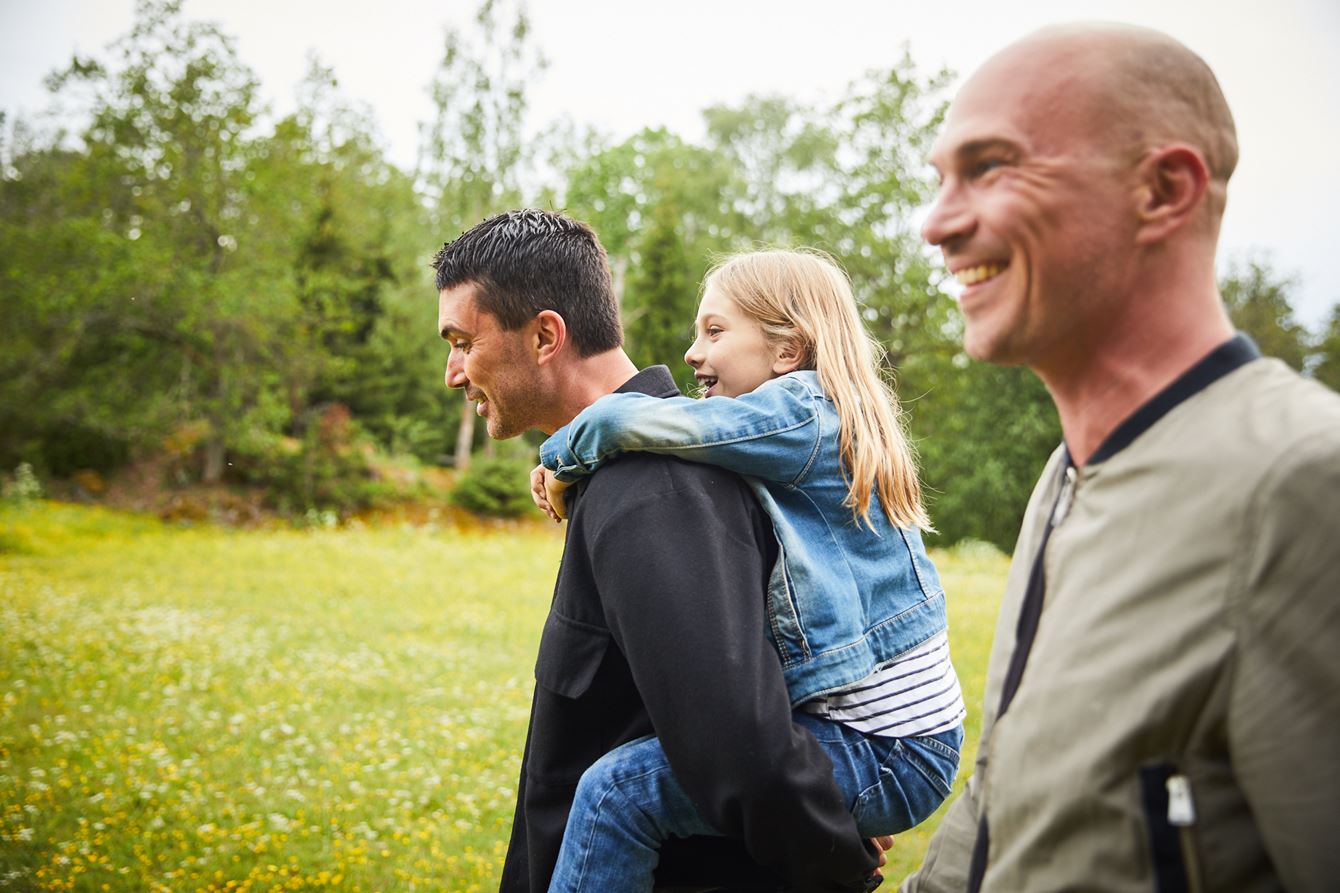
[{"x1": 800, "y1": 633, "x2": 967, "y2": 737}]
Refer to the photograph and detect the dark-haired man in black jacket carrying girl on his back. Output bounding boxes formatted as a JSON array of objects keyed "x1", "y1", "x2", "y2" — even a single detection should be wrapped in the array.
[{"x1": 433, "y1": 211, "x2": 876, "y2": 893}]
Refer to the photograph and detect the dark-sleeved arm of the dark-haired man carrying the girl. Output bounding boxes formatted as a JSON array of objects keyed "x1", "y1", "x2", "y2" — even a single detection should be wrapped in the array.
[{"x1": 582, "y1": 457, "x2": 876, "y2": 890}]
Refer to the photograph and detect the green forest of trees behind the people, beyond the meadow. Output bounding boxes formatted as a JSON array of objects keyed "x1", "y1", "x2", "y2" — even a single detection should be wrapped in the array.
[{"x1": 0, "y1": 0, "x2": 1340, "y2": 550}]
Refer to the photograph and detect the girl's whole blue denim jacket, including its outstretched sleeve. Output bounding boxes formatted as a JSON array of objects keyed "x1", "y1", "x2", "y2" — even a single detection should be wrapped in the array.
[{"x1": 540, "y1": 371, "x2": 947, "y2": 704}]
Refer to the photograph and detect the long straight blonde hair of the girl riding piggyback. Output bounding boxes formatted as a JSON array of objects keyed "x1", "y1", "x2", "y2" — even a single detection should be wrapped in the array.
[{"x1": 702, "y1": 249, "x2": 934, "y2": 531}]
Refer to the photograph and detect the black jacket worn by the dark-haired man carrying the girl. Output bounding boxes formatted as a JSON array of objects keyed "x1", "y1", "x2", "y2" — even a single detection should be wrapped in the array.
[{"x1": 501, "y1": 366, "x2": 875, "y2": 893}]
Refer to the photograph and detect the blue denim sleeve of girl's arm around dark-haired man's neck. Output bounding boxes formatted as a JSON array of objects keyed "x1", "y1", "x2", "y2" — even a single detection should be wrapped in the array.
[{"x1": 540, "y1": 373, "x2": 825, "y2": 484}]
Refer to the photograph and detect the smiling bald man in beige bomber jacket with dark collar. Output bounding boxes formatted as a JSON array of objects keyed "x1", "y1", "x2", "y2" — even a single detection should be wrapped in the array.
[{"x1": 905, "y1": 25, "x2": 1340, "y2": 893}]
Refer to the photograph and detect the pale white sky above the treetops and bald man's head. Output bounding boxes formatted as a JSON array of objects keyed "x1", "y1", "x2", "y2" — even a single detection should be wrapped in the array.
[{"x1": 0, "y1": 0, "x2": 1340, "y2": 326}]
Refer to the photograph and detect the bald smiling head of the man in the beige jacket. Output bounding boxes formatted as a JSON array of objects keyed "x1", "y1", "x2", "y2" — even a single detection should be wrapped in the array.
[{"x1": 922, "y1": 24, "x2": 1237, "y2": 379}]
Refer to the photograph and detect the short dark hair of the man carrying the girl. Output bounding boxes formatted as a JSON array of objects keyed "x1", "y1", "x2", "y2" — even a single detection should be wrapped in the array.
[{"x1": 433, "y1": 208, "x2": 623, "y2": 357}]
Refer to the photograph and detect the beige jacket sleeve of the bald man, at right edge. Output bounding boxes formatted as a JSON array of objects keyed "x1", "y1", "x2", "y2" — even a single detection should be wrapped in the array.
[{"x1": 1229, "y1": 432, "x2": 1340, "y2": 890}]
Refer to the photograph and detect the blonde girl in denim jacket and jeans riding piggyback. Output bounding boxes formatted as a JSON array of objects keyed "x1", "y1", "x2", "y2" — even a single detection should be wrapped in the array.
[{"x1": 533, "y1": 251, "x2": 965, "y2": 893}]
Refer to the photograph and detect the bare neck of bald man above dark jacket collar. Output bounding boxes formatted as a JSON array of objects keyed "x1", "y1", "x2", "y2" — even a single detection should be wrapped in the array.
[{"x1": 1036, "y1": 282, "x2": 1233, "y2": 465}]
